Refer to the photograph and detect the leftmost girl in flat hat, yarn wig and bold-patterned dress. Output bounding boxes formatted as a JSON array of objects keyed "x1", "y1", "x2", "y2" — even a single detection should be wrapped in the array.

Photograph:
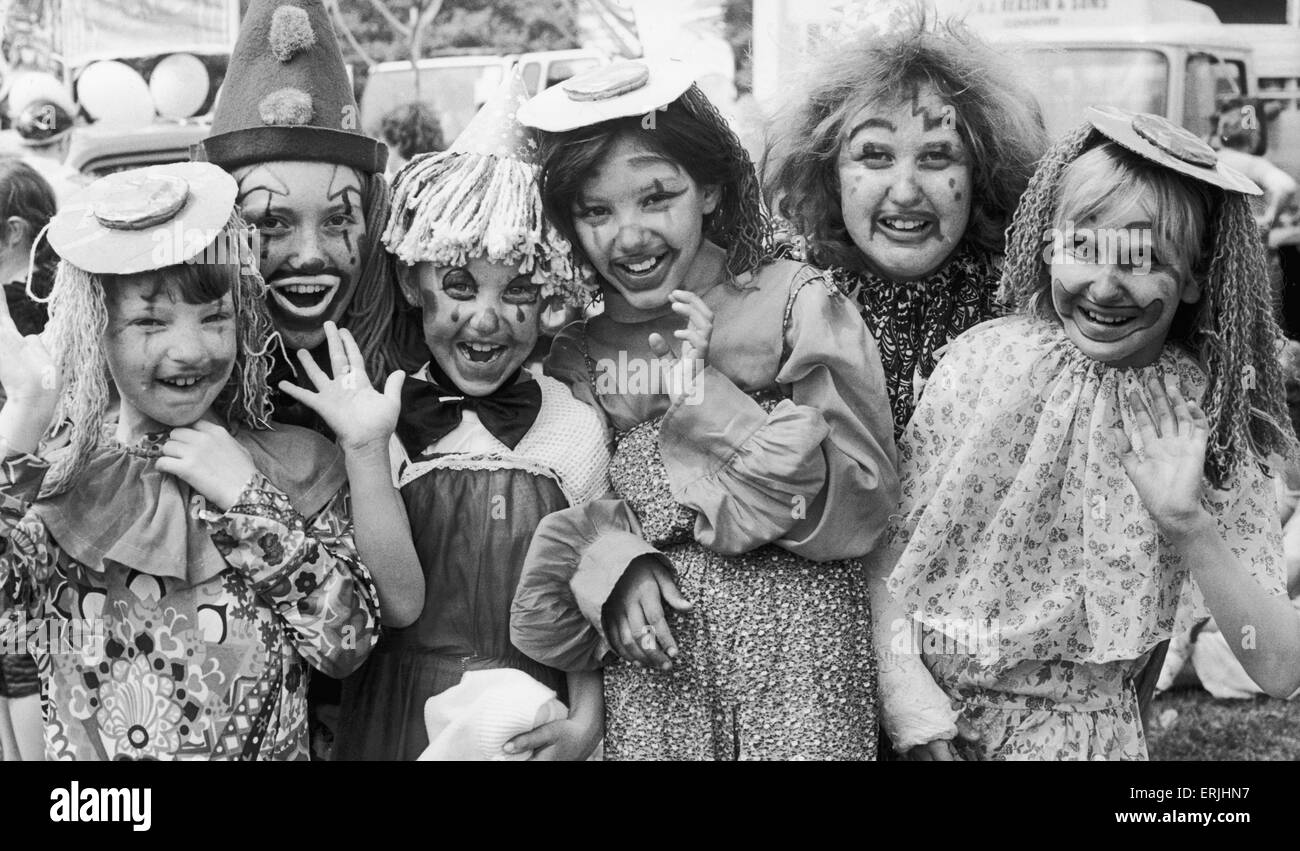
[{"x1": 0, "y1": 164, "x2": 378, "y2": 760}]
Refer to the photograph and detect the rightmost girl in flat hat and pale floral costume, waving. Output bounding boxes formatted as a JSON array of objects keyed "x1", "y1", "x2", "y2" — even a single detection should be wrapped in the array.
[{"x1": 874, "y1": 109, "x2": 1300, "y2": 760}]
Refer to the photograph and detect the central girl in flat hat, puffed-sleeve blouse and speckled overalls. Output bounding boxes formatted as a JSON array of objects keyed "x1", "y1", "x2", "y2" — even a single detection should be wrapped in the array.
[{"x1": 511, "y1": 61, "x2": 897, "y2": 759}]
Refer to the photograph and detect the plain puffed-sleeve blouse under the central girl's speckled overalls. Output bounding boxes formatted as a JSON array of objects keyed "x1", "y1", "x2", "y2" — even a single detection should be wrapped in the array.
[{"x1": 514, "y1": 255, "x2": 897, "y2": 670}]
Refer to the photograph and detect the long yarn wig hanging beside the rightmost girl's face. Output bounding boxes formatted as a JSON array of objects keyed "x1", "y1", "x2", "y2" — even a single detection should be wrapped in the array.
[{"x1": 998, "y1": 123, "x2": 1297, "y2": 487}]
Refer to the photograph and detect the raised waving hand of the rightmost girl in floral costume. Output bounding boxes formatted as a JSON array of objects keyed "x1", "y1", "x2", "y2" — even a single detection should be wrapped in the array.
[{"x1": 1115, "y1": 379, "x2": 1209, "y2": 531}]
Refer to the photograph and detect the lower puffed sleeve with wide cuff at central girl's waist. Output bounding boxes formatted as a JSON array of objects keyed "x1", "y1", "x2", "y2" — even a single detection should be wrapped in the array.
[{"x1": 510, "y1": 499, "x2": 671, "y2": 670}]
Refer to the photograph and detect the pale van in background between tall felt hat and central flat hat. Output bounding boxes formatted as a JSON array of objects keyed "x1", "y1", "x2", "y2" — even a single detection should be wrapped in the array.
[{"x1": 360, "y1": 51, "x2": 607, "y2": 143}]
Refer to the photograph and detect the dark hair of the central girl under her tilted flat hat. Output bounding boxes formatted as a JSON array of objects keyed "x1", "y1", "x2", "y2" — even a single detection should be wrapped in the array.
[{"x1": 538, "y1": 86, "x2": 772, "y2": 281}]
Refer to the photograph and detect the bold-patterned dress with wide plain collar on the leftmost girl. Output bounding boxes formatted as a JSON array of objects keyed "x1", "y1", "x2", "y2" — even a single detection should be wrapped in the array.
[{"x1": 0, "y1": 426, "x2": 378, "y2": 760}]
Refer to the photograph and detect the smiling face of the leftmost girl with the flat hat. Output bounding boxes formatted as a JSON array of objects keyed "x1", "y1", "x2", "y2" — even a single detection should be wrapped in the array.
[{"x1": 104, "y1": 275, "x2": 237, "y2": 435}]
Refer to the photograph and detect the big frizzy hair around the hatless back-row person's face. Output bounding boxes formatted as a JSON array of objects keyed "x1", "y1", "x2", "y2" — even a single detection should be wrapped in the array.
[{"x1": 763, "y1": 10, "x2": 1048, "y2": 270}]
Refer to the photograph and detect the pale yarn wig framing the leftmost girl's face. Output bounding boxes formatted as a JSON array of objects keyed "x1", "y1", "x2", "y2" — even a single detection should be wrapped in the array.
[{"x1": 42, "y1": 213, "x2": 274, "y2": 496}]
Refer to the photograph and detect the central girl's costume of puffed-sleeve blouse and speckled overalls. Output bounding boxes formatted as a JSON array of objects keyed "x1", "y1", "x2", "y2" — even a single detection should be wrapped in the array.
[{"x1": 511, "y1": 255, "x2": 897, "y2": 760}]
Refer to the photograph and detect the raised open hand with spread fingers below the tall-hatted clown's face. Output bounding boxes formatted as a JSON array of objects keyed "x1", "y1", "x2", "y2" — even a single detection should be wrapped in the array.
[{"x1": 280, "y1": 322, "x2": 406, "y2": 451}]
